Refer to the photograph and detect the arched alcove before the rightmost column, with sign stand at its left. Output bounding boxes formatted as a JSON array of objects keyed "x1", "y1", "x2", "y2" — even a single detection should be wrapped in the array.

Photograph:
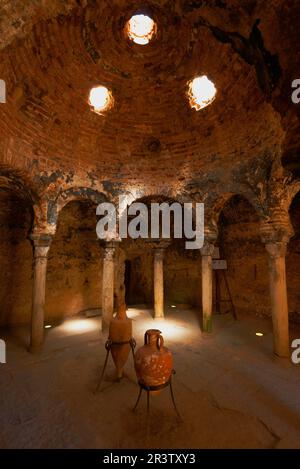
[{"x1": 216, "y1": 194, "x2": 271, "y2": 316}]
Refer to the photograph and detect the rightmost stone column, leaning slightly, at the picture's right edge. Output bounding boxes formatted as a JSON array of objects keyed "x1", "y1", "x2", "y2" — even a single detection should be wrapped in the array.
[{"x1": 266, "y1": 242, "x2": 290, "y2": 357}]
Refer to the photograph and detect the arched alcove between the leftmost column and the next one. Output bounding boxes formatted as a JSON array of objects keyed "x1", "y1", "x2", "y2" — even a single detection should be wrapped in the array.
[{"x1": 45, "y1": 200, "x2": 102, "y2": 322}]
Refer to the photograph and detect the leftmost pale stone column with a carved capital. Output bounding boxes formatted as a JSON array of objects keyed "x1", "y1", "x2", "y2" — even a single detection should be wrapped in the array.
[{"x1": 29, "y1": 234, "x2": 52, "y2": 353}]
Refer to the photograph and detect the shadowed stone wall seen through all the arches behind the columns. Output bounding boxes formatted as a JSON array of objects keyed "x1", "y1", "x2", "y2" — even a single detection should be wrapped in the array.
[{"x1": 0, "y1": 192, "x2": 300, "y2": 325}]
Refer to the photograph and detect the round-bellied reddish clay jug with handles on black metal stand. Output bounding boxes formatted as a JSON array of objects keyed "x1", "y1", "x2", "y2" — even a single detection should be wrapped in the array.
[{"x1": 134, "y1": 329, "x2": 173, "y2": 386}]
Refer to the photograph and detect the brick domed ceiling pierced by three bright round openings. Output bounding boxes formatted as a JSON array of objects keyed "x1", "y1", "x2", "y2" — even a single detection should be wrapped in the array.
[{"x1": 0, "y1": 0, "x2": 299, "y2": 199}]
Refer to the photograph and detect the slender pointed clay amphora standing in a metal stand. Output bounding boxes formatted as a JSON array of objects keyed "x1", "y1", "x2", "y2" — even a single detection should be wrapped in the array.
[{"x1": 109, "y1": 288, "x2": 132, "y2": 379}]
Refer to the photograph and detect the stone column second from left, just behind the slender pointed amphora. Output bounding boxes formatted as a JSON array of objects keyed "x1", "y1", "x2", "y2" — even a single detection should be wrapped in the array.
[{"x1": 102, "y1": 241, "x2": 116, "y2": 333}]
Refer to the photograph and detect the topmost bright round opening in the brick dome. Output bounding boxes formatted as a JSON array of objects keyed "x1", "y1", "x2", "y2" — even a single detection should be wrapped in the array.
[{"x1": 125, "y1": 14, "x2": 157, "y2": 46}]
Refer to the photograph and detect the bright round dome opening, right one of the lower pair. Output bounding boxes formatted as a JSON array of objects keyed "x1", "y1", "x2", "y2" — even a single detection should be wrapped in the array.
[{"x1": 188, "y1": 75, "x2": 217, "y2": 111}]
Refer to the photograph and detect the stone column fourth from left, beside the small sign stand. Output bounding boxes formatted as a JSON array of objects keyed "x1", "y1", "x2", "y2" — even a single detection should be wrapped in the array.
[{"x1": 201, "y1": 242, "x2": 214, "y2": 332}]
